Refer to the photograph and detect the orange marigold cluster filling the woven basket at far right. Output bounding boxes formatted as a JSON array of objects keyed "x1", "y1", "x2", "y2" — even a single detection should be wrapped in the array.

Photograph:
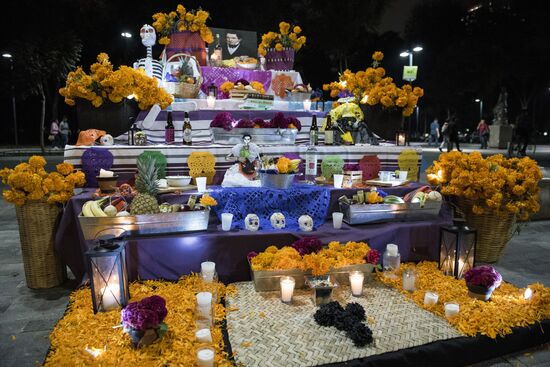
[{"x1": 426, "y1": 151, "x2": 542, "y2": 220}]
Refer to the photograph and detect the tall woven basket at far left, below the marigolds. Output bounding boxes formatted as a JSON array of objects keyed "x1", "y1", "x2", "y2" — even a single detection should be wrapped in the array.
[{"x1": 15, "y1": 202, "x2": 65, "y2": 288}]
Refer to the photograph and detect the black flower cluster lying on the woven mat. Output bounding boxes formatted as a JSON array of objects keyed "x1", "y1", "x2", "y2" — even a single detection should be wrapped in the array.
[{"x1": 313, "y1": 301, "x2": 373, "y2": 347}]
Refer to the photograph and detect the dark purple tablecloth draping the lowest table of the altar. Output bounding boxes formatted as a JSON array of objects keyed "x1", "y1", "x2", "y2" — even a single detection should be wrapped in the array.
[{"x1": 55, "y1": 184, "x2": 451, "y2": 283}]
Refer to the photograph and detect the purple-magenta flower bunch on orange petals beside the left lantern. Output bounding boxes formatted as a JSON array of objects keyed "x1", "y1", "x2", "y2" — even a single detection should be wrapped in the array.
[{"x1": 121, "y1": 296, "x2": 168, "y2": 330}]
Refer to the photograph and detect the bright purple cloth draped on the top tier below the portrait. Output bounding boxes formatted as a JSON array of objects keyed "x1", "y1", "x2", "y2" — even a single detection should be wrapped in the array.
[{"x1": 201, "y1": 66, "x2": 271, "y2": 99}]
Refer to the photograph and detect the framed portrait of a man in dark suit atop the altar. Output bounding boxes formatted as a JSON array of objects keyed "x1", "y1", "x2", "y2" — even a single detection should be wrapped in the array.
[{"x1": 208, "y1": 28, "x2": 258, "y2": 60}]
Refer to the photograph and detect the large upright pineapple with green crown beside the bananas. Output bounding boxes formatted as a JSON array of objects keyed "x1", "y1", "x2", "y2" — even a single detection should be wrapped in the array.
[{"x1": 130, "y1": 157, "x2": 159, "y2": 215}]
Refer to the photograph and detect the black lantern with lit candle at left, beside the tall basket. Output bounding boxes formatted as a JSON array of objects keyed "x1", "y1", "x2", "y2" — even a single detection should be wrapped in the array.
[{"x1": 85, "y1": 236, "x2": 130, "y2": 313}]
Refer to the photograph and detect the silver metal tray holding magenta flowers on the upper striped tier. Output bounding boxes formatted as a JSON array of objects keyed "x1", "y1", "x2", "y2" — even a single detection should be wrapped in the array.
[{"x1": 210, "y1": 127, "x2": 298, "y2": 145}]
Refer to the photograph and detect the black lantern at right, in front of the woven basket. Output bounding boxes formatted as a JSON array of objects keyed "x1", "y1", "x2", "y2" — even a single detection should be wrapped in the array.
[{"x1": 439, "y1": 219, "x2": 477, "y2": 279}]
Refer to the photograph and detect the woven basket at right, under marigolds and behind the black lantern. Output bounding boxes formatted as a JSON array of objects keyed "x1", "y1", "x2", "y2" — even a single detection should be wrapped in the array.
[{"x1": 454, "y1": 198, "x2": 516, "y2": 263}]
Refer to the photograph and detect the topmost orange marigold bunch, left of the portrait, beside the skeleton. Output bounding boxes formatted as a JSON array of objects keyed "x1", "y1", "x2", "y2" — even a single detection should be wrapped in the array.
[{"x1": 153, "y1": 4, "x2": 214, "y2": 45}]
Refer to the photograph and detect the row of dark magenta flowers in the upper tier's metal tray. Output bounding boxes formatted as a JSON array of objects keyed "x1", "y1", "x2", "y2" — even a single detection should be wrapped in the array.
[{"x1": 210, "y1": 112, "x2": 302, "y2": 131}]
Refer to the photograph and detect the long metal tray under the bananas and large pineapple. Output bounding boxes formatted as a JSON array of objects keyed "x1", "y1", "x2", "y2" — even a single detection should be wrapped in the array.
[{"x1": 78, "y1": 209, "x2": 210, "y2": 240}]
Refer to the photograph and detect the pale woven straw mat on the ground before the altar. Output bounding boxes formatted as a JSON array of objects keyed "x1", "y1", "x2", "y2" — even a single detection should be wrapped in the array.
[{"x1": 226, "y1": 281, "x2": 461, "y2": 367}]
